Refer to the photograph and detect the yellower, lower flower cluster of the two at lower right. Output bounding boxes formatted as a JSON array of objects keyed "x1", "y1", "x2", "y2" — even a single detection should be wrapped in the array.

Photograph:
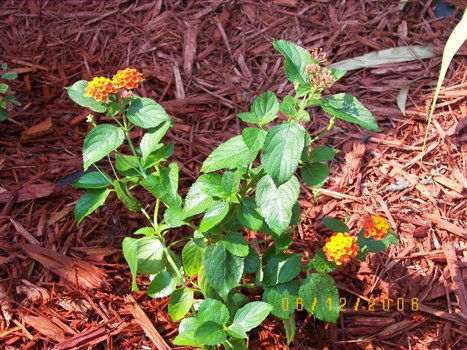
[{"x1": 323, "y1": 232, "x2": 360, "y2": 265}]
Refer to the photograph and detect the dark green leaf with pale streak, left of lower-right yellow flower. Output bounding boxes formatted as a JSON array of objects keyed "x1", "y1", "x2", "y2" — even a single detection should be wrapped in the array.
[{"x1": 263, "y1": 254, "x2": 302, "y2": 287}]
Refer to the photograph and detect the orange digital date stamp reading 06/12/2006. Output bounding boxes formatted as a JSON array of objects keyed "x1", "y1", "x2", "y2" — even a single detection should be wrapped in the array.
[{"x1": 281, "y1": 297, "x2": 418, "y2": 312}]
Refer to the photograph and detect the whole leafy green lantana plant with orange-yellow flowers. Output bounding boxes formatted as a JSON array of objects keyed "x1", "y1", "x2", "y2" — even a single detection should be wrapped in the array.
[{"x1": 67, "y1": 40, "x2": 397, "y2": 350}]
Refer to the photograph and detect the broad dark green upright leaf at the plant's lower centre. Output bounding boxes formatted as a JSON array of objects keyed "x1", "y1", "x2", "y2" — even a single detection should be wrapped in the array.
[{"x1": 204, "y1": 243, "x2": 243, "y2": 299}]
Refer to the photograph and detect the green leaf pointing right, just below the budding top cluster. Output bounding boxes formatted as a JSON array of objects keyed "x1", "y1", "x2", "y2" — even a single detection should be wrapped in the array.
[{"x1": 321, "y1": 93, "x2": 379, "y2": 131}]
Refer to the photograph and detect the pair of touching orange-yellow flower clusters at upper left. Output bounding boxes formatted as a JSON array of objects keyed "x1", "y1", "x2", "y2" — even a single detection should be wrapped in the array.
[{"x1": 84, "y1": 68, "x2": 144, "y2": 102}]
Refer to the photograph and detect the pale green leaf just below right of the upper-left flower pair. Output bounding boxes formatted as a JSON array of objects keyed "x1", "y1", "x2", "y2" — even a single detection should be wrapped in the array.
[{"x1": 127, "y1": 97, "x2": 170, "y2": 129}]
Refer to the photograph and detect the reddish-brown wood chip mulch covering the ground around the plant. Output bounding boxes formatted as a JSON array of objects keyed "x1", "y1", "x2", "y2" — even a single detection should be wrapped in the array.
[{"x1": 0, "y1": 0, "x2": 467, "y2": 349}]
